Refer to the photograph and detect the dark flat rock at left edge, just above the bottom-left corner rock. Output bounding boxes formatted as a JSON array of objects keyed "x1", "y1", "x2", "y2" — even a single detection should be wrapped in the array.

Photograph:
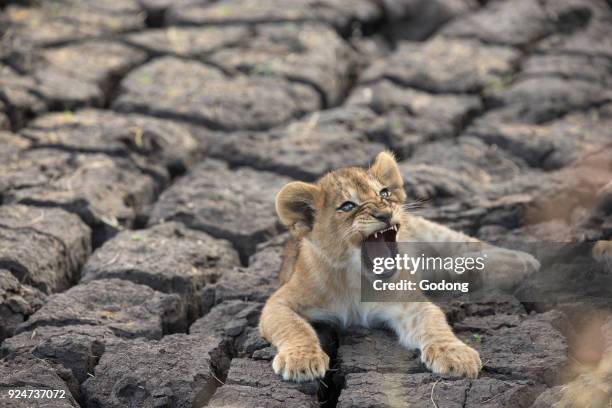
[{"x1": 0, "y1": 325, "x2": 118, "y2": 383}]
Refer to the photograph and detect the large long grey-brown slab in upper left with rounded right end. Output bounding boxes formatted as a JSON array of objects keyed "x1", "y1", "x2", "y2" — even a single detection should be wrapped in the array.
[{"x1": 113, "y1": 57, "x2": 320, "y2": 131}]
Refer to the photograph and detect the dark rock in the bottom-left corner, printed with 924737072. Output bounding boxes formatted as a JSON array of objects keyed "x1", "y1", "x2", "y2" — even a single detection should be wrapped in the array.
[{"x1": 0, "y1": 356, "x2": 79, "y2": 408}]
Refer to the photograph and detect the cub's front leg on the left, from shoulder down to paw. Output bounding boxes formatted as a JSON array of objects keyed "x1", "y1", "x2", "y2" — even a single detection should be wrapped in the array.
[{"x1": 259, "y1": 285, "x2": 329, "y2": 382}]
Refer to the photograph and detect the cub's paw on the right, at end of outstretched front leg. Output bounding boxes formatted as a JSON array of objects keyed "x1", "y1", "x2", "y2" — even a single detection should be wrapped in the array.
[{"x1": 421, "y1": 340, "x2": 482, "y2": 378}]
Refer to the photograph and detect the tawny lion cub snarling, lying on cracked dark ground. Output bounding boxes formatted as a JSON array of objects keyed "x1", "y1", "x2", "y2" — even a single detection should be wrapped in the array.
[{"x1": 259, "y1": 152, "x2": 512, "y2": 381}]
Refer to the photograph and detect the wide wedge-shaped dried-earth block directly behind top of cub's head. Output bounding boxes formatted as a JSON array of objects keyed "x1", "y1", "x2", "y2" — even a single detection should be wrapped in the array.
[{"x1": 212, "y1": 107, "x2": 385, "y2": 180}]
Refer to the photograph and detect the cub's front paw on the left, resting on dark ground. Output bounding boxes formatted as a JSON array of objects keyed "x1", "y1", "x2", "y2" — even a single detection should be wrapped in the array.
[{"x1": 272, "y1": 346, "x2": 329, "y2": 382}]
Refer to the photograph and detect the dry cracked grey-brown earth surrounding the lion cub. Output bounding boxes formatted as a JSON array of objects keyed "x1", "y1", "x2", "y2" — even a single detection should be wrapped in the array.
[{"x1": 0, "y1": 0, "x2": 612, "y2": 408}]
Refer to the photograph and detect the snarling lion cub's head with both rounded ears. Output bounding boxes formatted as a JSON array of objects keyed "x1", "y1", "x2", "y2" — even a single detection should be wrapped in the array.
[{"x1": 276, "y1": 152, "x2": 406, "y2": 257}]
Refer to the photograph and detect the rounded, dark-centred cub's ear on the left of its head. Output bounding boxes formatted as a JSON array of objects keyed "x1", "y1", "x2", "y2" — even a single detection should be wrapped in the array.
[{"x1": 276, "y1": 181, "x2": 321, "y2": 236}]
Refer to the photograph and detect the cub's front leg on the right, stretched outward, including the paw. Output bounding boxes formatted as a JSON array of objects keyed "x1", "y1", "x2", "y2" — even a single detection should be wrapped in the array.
[{"x1": 382, "y1": 301, "x2": 482, "y2": 378}]
